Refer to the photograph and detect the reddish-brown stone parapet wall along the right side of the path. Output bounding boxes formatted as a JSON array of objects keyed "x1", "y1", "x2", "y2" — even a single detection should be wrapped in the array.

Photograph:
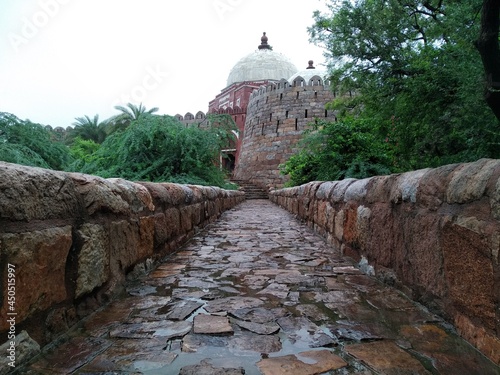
[{"x1": 270, "y1": 159, "x2": 500, "y2": 364}]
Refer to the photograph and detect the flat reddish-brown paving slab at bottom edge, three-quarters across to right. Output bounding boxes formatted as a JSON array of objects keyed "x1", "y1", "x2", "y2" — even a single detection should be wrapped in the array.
[{"x1": 345, "y1": 341, "x2": 431, "y2": 375}]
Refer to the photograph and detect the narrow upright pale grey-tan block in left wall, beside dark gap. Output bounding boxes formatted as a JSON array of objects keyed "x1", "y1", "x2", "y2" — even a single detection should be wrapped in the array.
[{"x1": 75, "y1": 224, "x2": 109, "y2": 298}]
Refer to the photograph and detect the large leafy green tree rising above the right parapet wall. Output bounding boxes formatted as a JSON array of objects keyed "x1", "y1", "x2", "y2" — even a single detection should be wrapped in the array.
[{"x1": 309, "y1": 0, "x2": 500, "y2": 174}]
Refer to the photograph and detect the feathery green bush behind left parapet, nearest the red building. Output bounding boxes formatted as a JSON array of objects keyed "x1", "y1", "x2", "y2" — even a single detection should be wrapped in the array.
[{"x1": 75, "y1": 114, "x2": 236, "y2": 186}]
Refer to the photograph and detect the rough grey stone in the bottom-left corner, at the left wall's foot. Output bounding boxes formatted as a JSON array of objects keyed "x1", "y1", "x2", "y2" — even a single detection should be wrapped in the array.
[{"x1": 0, "y1": 331, "x2": 40, "y2": 375}]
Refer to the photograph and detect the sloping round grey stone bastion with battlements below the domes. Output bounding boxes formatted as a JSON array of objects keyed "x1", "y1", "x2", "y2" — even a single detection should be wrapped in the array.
[{"x1": 234, "y1": 76, "x2": 335, "y2": 187}]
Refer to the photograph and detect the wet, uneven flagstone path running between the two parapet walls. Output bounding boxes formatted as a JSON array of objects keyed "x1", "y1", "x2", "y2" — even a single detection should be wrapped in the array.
[{"x1": 24, "y1": 200, "x2": 500, "y2": 375}]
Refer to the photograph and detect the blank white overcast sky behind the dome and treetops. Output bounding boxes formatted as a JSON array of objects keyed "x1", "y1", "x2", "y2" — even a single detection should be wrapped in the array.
[{"x1": 0, "y1": 0, "x2": 326, "y2": 127}]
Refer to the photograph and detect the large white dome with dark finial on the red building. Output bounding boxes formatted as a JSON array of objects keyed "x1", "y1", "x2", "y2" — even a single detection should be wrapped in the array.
[{"x1": 227, "y1": 33, "x2": 298, "y2": 86}]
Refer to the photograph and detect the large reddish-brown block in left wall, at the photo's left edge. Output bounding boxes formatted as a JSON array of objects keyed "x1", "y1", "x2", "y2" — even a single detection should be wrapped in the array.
[{"x1": 0, "y1": 226, "x2": 72, "y2": 330}]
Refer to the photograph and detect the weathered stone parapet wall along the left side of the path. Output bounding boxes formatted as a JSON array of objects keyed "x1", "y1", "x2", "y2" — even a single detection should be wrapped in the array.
[{"x1": 0, "y1": 162, "x2": 245, "y2": 345}]
